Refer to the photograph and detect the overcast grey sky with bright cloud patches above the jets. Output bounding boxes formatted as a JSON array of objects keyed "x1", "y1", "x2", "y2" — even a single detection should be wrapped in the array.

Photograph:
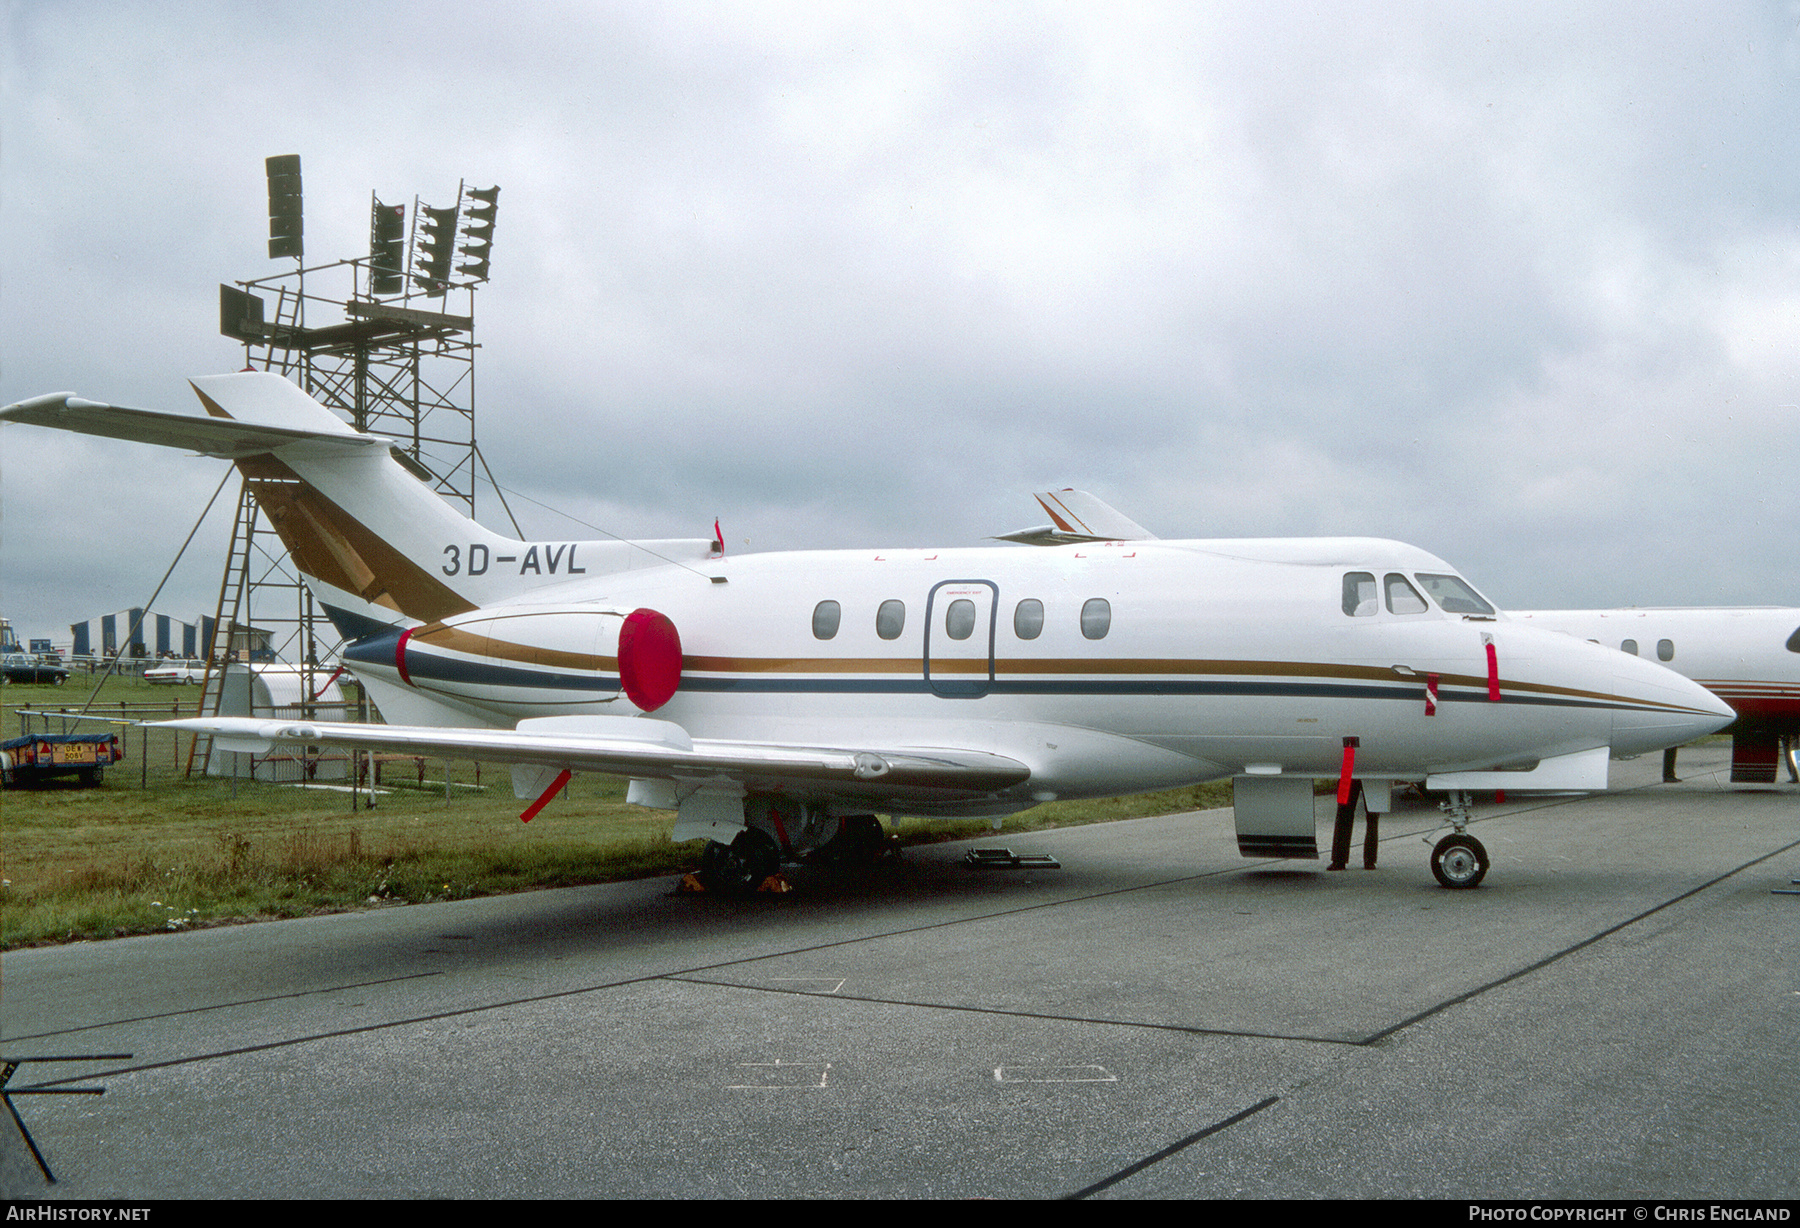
[{"x1": 0, "y1": 0, "x2": 1800, "y2": 639}]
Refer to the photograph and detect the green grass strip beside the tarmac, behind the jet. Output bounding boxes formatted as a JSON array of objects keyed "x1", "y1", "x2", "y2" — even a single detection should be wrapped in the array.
[{"x1": 0, "y1": 675, "x2": 1231, "y2": 949}]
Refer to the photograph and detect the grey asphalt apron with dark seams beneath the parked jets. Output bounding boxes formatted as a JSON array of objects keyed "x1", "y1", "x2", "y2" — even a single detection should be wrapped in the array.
[{"x1": 0, "y1": 745, "x2": 1800, "y2": 1199}]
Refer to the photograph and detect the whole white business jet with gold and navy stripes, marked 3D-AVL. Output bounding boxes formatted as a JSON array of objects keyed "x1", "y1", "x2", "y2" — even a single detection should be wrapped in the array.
[{"x1": 0, "y1": 373, "x2": 1732, "y2": 888}]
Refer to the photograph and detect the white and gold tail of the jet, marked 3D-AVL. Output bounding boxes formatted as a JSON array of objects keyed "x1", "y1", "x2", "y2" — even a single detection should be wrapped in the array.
[{"x1": 0, "y1": 371, "x2": 715, "y2": 639}]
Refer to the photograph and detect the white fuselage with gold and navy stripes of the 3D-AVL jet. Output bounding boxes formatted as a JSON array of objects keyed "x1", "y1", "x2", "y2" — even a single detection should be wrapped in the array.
[{"x1": 346, "y1": 538, "x2": 1717, "y2": 812}]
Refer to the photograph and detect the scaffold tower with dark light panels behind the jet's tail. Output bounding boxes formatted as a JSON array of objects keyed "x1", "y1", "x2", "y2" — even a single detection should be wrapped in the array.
[{"x1": 190, "y1": 155, "x2": 517, "y2": 763}]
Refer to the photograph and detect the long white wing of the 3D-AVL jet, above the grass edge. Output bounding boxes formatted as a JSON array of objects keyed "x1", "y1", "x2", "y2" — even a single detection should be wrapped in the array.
[{"x1": 155, "y1": 717, "x2": 1031, "y2": 799}]
